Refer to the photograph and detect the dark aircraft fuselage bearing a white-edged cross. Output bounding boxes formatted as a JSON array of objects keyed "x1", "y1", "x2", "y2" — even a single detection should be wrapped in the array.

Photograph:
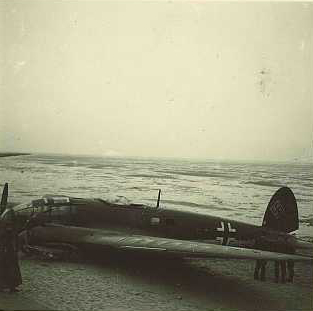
[{"x1": 21, "y1": 199, "x2": 262, "y2": 250}]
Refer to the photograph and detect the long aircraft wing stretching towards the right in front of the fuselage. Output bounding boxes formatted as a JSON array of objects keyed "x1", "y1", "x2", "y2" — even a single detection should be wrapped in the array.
[{"x1": 31, "y1": 225, "x2": 312, "y2": 262}]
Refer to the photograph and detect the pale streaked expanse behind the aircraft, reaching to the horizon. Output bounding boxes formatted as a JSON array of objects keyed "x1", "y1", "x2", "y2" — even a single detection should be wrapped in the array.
[{"x1": 0, "y1": 154, "x2": 313, "y2": 240}]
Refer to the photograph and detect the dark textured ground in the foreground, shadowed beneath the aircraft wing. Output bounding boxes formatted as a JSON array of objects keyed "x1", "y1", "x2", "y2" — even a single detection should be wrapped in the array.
[{"x1": 0, "y1": 256, "x2": 313, "y2": 311}]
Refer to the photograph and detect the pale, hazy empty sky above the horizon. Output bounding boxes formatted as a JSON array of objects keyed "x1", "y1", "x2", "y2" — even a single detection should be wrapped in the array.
[{"x1": 0, "y1": 0, "x2": 313, "y2": 160}]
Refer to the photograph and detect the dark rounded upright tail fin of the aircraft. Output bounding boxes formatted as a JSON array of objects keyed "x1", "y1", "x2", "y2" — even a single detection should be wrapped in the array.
[{"x1": 262, "y1": 187, "x2": 299, "y2": 233}]
